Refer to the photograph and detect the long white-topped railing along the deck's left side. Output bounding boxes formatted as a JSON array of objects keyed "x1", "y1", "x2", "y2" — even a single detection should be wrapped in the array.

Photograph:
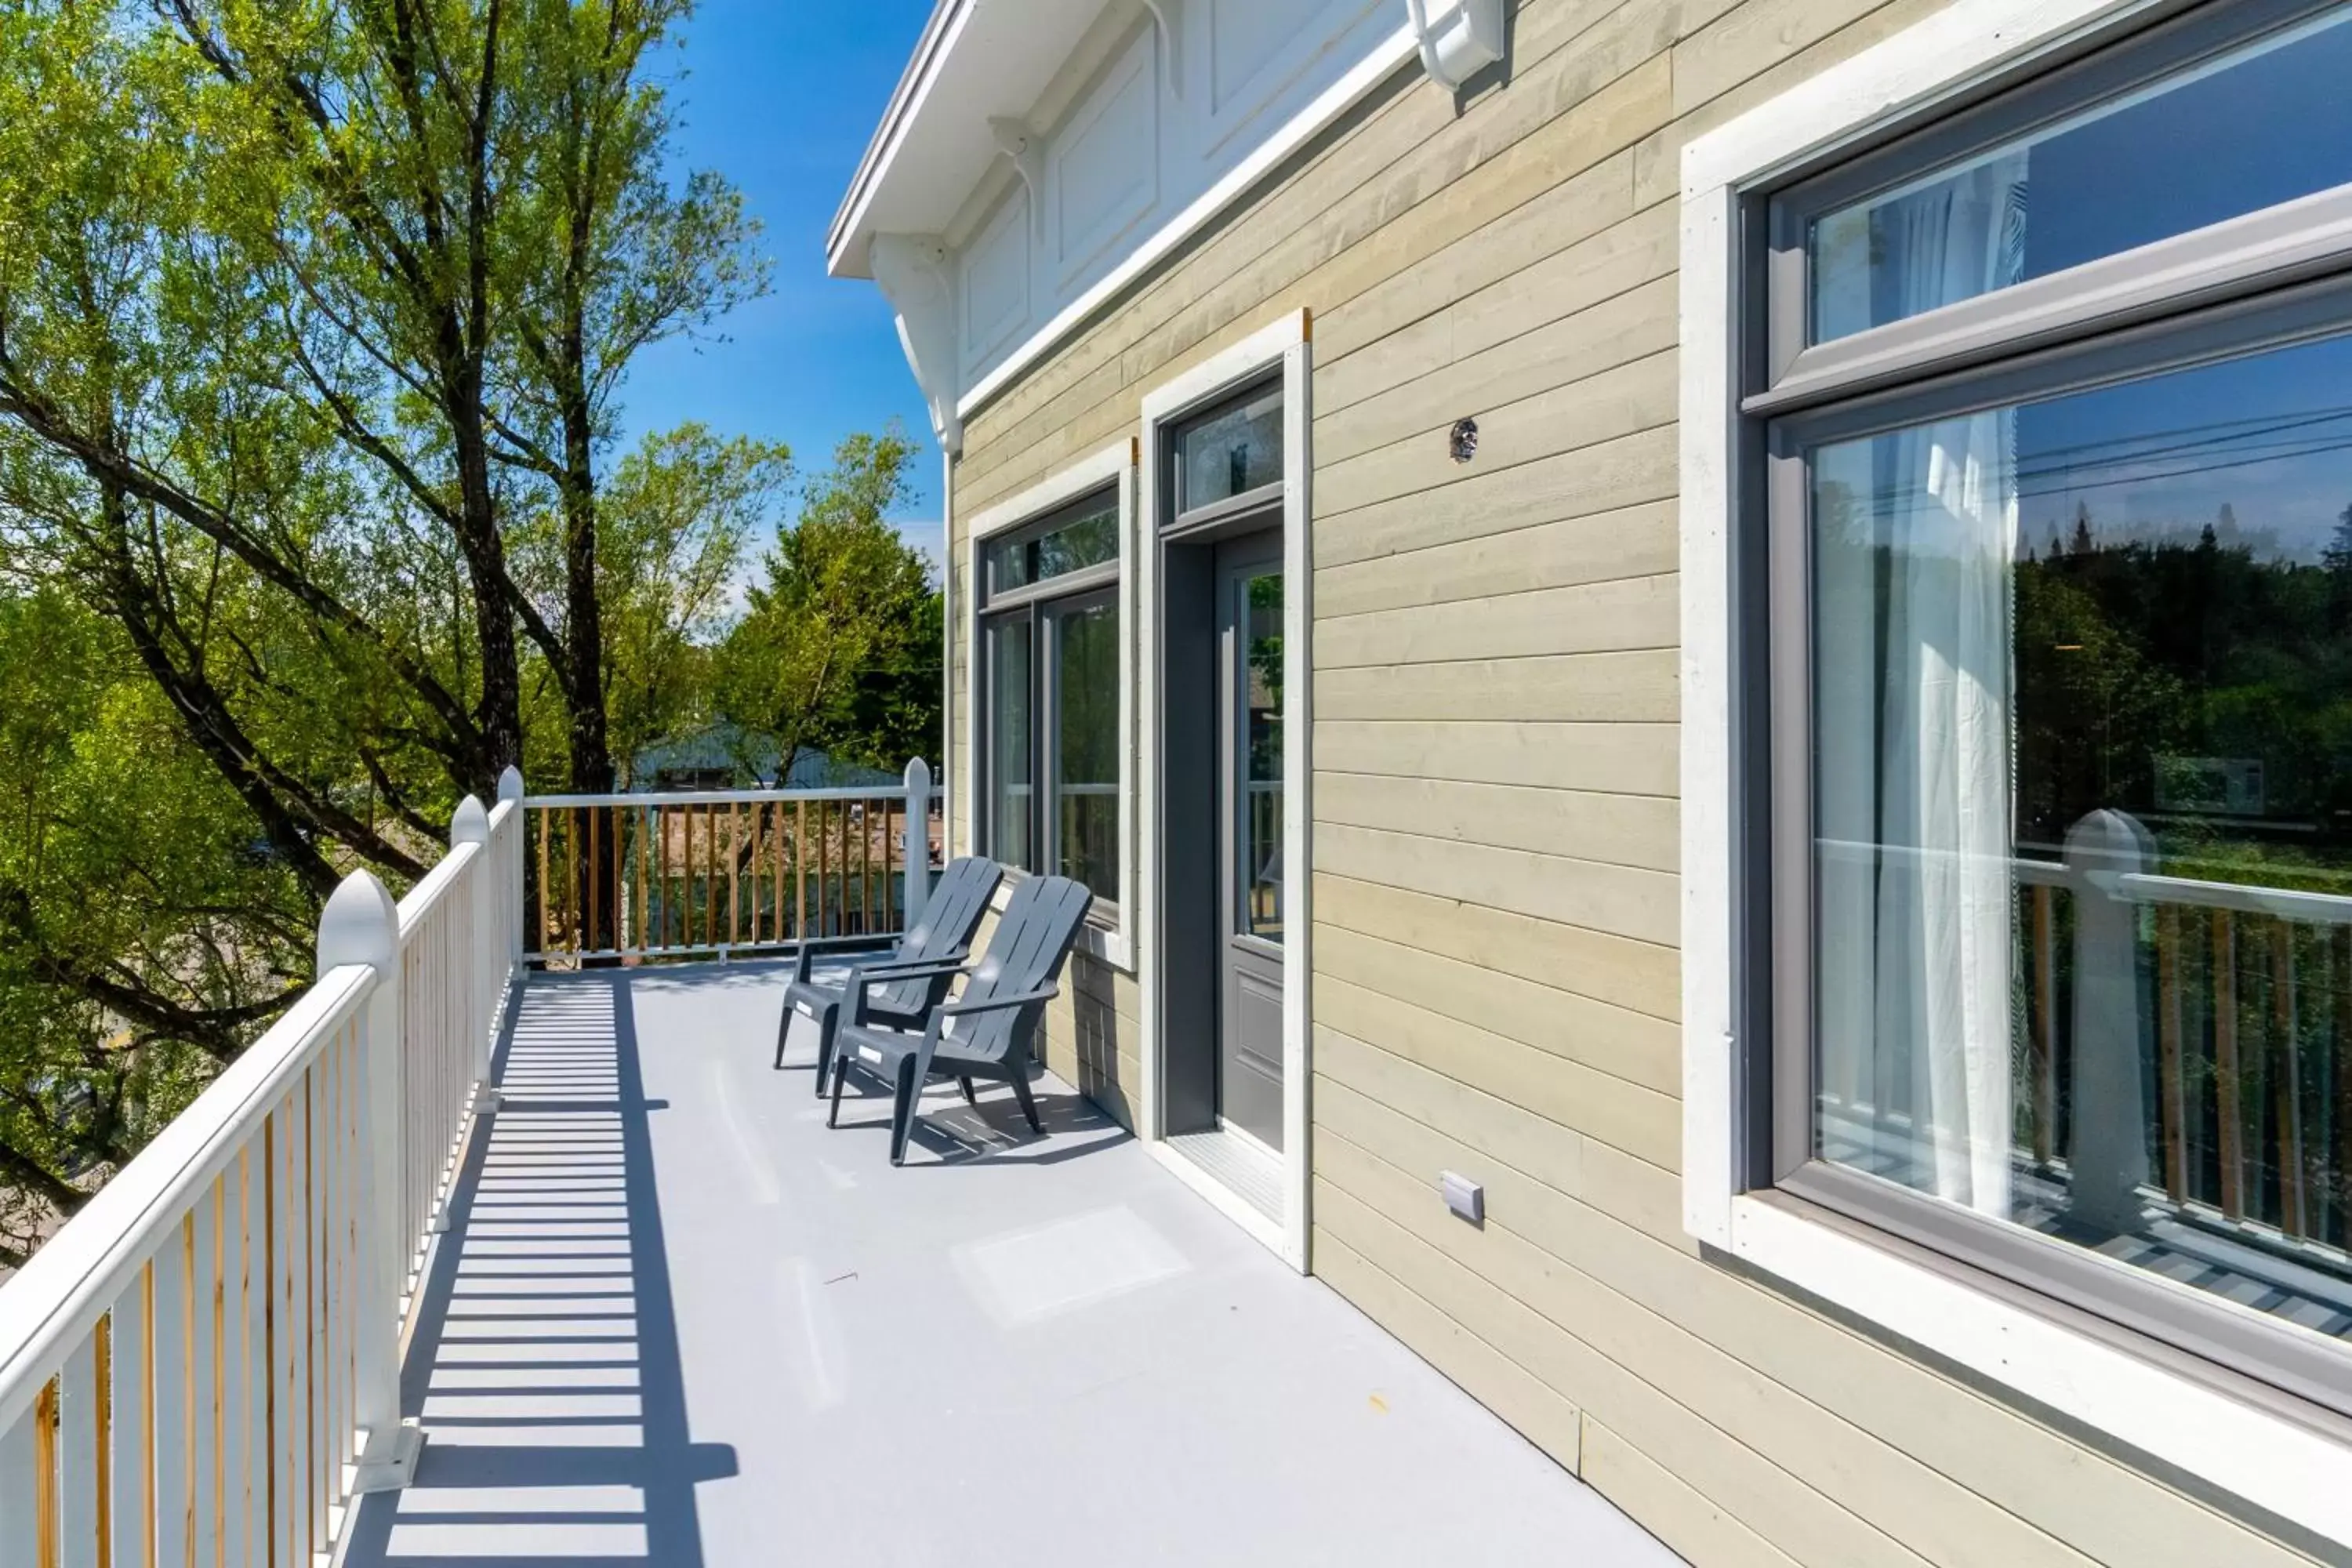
[{"x1": 0, "y1": 771, "x2": 522, "y2": 1568}]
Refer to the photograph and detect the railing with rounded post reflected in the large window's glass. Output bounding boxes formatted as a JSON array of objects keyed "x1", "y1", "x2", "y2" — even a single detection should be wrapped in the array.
[{"x1": 1820, "y1": 811, "x2": 2352, "y2": 1269}]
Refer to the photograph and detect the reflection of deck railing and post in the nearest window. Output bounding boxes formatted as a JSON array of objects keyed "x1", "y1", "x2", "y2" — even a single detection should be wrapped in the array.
[{"x1": 1816, "y1": 811, "x2": 2352, "y2": 1338}]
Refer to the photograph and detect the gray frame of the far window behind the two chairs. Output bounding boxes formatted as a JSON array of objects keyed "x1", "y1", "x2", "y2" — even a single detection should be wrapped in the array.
[{"x1": 971, "y1": 485, "x2": 1127, "y2": 926}]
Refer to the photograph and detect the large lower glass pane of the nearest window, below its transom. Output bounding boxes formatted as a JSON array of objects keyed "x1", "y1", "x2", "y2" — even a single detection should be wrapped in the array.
[{"x1": 1806, "y1": 339, "x2": 2352, "y2": 1338}]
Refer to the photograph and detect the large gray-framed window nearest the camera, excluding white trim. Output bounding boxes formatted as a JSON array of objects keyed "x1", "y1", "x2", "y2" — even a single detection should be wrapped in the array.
[{"x1": 1745, "y1": 0, "x2": 2352, "y2": 1410}]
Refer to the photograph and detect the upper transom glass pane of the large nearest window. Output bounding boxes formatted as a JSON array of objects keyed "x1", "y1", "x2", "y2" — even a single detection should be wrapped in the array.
[{"x1": 1806, "y1": 7, "x2": 2352, "y2": 343}]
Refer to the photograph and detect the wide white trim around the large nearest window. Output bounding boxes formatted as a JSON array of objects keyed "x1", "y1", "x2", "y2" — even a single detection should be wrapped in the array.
[{"x1": 1682, "y1": 0, "x2": 2352, "y2": 1544}]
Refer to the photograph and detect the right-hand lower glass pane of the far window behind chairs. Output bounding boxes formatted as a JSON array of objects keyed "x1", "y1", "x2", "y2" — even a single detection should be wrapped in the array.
[{"x1": 1054, "y1": 600, "x2": 1120, "y2": 900}]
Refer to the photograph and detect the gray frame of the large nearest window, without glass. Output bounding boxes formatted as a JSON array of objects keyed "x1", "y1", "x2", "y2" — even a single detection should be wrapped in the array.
[{"x1": 1733, "y1": 0, "x2": 2352, "y2": 1425}]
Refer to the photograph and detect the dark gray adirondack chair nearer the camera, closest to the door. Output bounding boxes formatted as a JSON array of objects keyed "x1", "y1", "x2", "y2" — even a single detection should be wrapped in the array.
[{"x1": 826, "y1": 877, "x2": 1094, "y2": 1166}]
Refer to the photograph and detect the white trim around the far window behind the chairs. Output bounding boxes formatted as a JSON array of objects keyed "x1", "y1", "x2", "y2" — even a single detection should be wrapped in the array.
[{"x1": 957, "y1": 440, "x2": 1136, "y2": 973}]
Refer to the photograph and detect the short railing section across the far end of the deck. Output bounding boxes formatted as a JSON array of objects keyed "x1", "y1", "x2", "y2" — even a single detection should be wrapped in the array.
[{"x1": 524, "y1": 760, "x2": 934, "y2": 966}]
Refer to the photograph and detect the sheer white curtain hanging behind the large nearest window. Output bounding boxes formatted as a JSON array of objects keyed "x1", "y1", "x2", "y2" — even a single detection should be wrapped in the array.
[{"x1": 1813, "y1": 155, "x2": 2025, "y2": 1213}]
